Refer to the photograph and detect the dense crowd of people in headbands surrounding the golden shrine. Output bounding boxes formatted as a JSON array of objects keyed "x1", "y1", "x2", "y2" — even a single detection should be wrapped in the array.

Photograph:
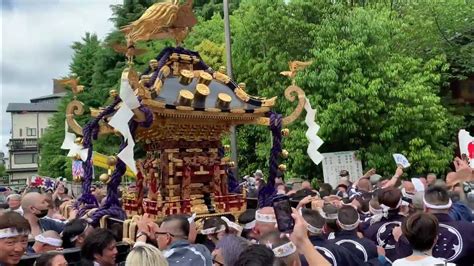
[{"x1": 0, "y1": 159, "x2": 474, "y2": 266}]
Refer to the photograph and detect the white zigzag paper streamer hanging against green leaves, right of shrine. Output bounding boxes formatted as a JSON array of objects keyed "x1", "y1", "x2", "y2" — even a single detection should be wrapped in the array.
[{"x1": 304, "y1": 98, "x2": 324, "y2": 164}]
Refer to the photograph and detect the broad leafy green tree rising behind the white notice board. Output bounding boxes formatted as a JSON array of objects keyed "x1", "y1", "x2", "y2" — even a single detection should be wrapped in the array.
[{"x1": 298, "y1": 8, "x2": 459, "y2": 177}]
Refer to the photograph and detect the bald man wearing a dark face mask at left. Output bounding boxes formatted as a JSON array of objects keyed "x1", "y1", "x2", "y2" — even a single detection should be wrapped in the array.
[{"x1": 21, "y1": 192, "x2": 64, "y2": 237}]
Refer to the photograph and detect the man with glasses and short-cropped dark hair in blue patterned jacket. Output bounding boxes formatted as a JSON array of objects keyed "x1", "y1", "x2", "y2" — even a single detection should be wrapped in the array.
[{"x1": 155, "y1": 215, "x2": 212, "y2": 266}]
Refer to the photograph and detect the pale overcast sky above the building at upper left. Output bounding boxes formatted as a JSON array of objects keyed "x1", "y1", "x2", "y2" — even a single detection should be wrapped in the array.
[{"x1": 0, "y1": 0, "x2": 123, "y2": 153}]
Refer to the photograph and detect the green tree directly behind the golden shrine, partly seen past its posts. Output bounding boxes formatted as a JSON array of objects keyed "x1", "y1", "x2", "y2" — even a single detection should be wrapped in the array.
[{"x1": 231, "y1": 0, "x2": 333, "y2": 177}]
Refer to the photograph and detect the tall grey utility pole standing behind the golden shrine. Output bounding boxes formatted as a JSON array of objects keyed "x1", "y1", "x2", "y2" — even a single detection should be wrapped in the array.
[{"x1": 224, "y1": 0, "x2": 239, "y2": 179}]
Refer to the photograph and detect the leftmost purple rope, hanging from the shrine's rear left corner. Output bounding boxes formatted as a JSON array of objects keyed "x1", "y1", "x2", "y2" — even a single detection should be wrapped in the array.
[{"x1": 74, "y1": 96, "x2": 121, "y2": 216}]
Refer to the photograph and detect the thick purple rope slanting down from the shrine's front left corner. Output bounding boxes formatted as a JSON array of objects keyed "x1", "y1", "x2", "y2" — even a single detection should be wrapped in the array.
[{"x1": 91, "y1": 106, "x2": 153, "y2": 226}]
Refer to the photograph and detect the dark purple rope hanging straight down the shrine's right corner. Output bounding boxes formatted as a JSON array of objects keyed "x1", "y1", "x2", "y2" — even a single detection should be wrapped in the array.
[{"x1": 258, "y1": 112, "x2": 282, "y2": 208}]
